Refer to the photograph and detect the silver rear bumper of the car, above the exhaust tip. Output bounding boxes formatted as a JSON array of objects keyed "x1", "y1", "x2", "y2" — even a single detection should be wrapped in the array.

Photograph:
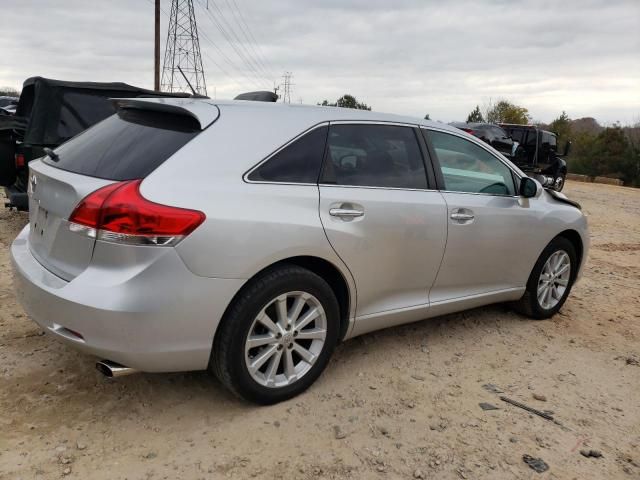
[{"x1": 11, "y1": 226, "x2": 244, "y2": 372}]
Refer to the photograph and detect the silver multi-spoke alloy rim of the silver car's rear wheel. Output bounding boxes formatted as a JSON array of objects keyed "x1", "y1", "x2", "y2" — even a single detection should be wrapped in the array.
[{"x1": 245, "y1": 291, "x2": 327, "y2": 388}]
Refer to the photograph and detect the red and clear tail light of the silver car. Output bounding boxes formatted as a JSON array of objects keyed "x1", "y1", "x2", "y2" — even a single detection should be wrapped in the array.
[{"x1": 69, "y1": 180, "x2": 206, "y2": 246}]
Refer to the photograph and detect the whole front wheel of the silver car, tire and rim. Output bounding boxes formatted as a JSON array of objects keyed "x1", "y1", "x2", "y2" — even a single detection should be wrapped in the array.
[{"x1": 514, "y1": 237, "x2": 578, "y2": 320}]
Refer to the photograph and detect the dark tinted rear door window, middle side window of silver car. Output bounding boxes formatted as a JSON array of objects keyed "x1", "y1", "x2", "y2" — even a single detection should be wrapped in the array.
[{"x1": 323, "y1": 125, "x2": 427, "y2": 188}]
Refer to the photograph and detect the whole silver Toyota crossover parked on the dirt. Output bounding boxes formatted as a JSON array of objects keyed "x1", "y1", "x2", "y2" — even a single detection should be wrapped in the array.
[{"x1": 11, "y1": 99, "x2": 589, "y2": 404}]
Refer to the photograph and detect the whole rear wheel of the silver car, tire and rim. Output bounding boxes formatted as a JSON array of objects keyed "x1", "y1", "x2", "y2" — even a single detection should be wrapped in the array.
[{"x1": 211, "y1": 266, "x2": 339, "y2": 404}]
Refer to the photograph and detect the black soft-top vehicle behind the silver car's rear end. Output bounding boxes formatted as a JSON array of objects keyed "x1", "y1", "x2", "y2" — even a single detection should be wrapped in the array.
[{"x1": 0, "y1": 77, "x2": 190, "y2": 210}]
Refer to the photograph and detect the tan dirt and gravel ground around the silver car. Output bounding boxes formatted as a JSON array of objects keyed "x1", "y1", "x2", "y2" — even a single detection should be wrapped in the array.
[{"x1": 0, "y1": 182, "x2": 640, "y2": 480}]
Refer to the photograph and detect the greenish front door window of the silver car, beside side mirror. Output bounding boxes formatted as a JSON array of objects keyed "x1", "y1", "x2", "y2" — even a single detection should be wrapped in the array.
[{"x1": 428, "y1": 131, "x2": 515, "y2": 195}]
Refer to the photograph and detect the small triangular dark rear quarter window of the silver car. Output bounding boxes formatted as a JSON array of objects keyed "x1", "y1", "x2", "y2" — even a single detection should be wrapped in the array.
[{"x1": 249, "y1": 127, "x2": 328, "y2": 183}]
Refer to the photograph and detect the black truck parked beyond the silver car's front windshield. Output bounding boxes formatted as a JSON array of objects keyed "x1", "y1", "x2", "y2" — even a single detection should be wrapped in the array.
[{"x1": 500, "y1": 123, "x2": 571, "y2": 192}]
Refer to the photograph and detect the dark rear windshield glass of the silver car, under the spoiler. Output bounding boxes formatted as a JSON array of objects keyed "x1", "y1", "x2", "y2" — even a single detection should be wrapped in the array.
[{"x1": 44, "y1": 109, "x2": 200, "y2": 180}]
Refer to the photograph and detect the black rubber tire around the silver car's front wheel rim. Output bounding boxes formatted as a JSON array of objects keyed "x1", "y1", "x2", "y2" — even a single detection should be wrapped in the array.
[{"x1": 513, "y1": 237, "x2": 578, "y2": 320}]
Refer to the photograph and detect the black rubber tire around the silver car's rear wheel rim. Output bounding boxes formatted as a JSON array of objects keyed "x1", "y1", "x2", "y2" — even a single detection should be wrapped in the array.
[{"x1": 209, "y1": 264, "x2": 340, "y2": 405}]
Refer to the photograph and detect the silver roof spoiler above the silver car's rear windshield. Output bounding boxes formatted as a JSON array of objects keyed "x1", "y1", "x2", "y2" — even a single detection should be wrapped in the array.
[{"x1": 111, "y1": 98, "x2": 220, "y2": 130}]
